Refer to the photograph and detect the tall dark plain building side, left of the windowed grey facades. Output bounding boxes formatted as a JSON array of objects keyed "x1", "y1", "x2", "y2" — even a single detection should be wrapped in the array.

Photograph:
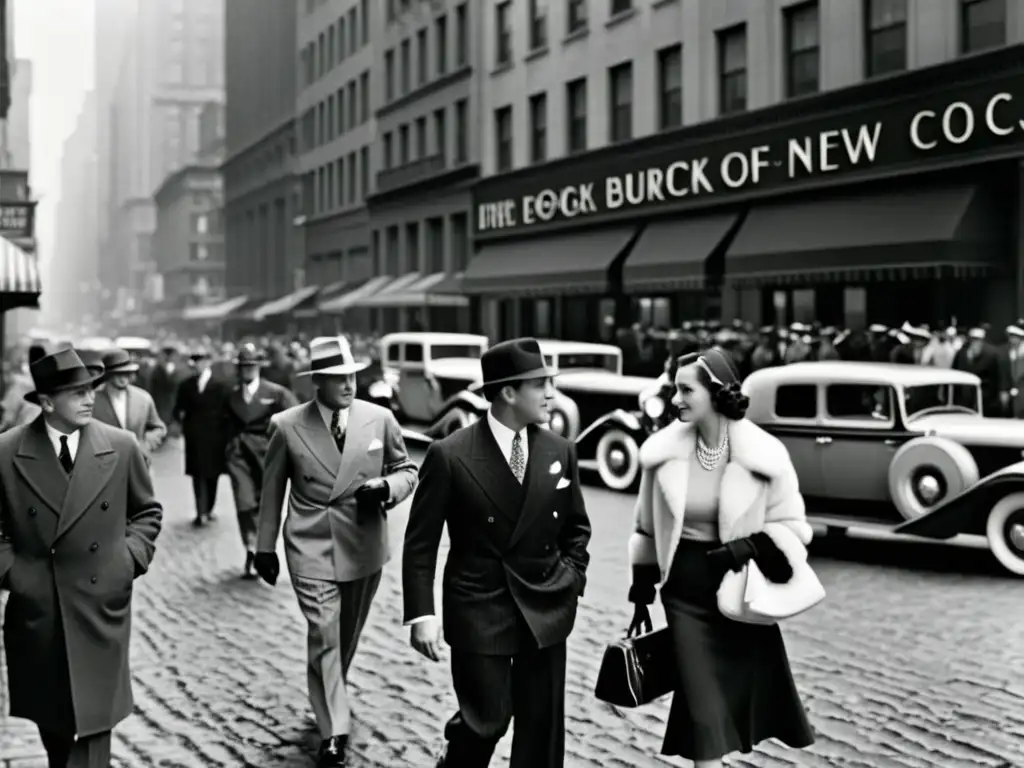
[{"x1": 222, "y1": 0, "x2": 304, "y2": 307}]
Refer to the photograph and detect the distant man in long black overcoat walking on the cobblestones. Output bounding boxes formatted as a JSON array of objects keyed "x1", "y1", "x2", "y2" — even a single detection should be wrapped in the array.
[{"x1": 174, "y1": 347, "x2": 229, "y2": 526}]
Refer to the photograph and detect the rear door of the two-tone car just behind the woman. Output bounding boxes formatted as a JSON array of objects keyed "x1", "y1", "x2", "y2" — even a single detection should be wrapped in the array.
[{"x1": 765, "y1": 384, "x2": 825, "y2": 497}]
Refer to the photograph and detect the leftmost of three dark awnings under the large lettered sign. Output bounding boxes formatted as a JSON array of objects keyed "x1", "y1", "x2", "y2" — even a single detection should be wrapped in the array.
[{"x1": 462, "y1": 226, "x2": 637, "y2": 296}]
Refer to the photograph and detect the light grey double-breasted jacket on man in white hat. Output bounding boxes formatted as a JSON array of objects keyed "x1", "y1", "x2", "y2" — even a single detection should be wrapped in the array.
[{"x1": 256, "y1": 400, "x2": 416, "y2": 582}]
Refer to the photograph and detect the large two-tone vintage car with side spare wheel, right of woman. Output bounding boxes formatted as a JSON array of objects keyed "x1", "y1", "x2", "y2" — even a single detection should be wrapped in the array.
[{"x1": 743, "y1": 361, "x2": 1024, "y2": 575}]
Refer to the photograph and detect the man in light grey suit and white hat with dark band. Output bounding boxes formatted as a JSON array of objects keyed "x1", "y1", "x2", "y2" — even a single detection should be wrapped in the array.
[{"x1": 256, "y1": 337, "x2": 416, "y2": 766}]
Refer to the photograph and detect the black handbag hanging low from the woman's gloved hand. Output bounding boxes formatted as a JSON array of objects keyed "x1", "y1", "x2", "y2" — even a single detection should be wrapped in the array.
[{"x1": 594, "y1": 627, "x2": 678, "y2": 708}]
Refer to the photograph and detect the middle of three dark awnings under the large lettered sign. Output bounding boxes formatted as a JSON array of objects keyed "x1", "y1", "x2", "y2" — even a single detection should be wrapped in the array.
[{"x1": 623, "y1": 213, "x2": 739, "y2": 293}]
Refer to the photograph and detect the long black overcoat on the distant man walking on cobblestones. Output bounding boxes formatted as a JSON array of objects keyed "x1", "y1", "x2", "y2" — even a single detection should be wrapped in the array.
[{"x1": 174, "y1": 374, "x2": 231, "y2": 477}]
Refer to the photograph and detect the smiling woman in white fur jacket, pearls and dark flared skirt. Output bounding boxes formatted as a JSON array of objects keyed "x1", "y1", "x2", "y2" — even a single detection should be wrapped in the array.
[{"x1": 630, "y1": 348, "x2": 814, "y2": 768}]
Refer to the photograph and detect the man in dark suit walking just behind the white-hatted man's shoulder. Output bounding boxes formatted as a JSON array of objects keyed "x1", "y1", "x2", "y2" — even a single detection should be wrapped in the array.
[{"x1": 223, "y1": 343, "x2": 298, "y2": 579}]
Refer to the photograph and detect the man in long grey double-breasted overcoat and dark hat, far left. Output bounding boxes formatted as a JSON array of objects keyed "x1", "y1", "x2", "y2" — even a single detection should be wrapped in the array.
[{"x1": 0, "y1": 349, "x2": 163, "y2": 768}]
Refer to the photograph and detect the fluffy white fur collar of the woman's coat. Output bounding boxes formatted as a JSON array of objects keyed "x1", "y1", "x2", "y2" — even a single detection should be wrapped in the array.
[{"x1": 640, "y1": 419, "x2": 790, "y2": 479}]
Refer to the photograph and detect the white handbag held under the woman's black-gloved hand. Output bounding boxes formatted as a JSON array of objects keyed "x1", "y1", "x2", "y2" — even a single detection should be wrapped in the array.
[{"x1": 718, "y1": 560, "x2": 825, "y2": 625}]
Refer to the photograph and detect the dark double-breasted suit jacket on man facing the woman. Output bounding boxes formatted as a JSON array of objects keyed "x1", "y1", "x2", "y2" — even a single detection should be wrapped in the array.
[{"x1": 401, "y1": 419, "x2": 591, "y2": 654}]
